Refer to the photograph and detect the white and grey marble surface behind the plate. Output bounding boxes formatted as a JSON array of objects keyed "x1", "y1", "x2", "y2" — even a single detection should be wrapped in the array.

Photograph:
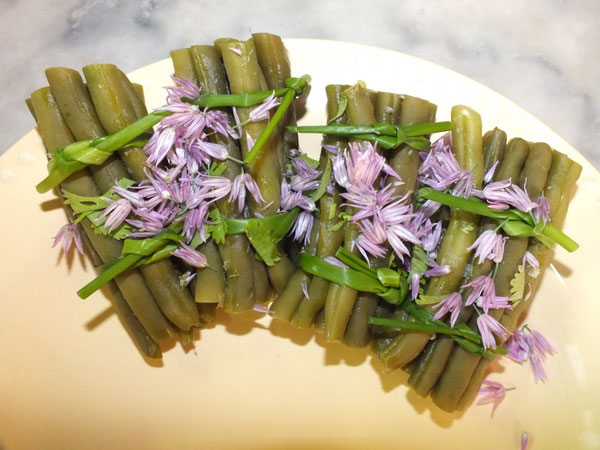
[{"x1": 0, "y1": 0, "x2": 600, "y2": 168}]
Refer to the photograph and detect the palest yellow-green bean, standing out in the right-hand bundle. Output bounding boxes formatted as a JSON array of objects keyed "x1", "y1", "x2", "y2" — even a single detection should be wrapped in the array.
[{"x1": 380, "y1": 106, "x2": 483, "y2": 369}]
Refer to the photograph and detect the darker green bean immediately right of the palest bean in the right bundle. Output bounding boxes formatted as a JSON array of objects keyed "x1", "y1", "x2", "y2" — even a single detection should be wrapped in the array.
[{"x1": 408, "y1": 128, "x2": 506, "y2": 397}]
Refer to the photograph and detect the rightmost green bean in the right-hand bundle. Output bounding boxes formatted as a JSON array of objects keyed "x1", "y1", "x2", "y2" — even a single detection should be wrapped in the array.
[{"x1": 457, "y1": 149, "x2": 581, "y2": 409}]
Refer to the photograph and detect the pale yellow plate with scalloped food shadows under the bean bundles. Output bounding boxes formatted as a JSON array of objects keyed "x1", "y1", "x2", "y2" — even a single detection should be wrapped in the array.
[{"x1": 0, "y1": 39, "x2": 600, "y2": 449}]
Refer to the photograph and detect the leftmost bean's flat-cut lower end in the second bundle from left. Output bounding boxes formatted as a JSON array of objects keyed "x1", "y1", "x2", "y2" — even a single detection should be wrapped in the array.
[{"x1": 194, "y1": 240, "x2": 225, "y2": 303}]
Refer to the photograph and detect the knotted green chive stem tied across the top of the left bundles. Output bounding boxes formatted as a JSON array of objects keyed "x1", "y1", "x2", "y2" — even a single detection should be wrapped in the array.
[{"x1": 36, "y1": 75, "x2": 311, "y2": 193}]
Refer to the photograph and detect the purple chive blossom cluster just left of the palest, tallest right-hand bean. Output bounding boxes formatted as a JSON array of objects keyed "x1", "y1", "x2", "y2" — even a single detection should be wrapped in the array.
[{"x1": 418, "y1": 133, "x2": 473, "y2": 198}]
